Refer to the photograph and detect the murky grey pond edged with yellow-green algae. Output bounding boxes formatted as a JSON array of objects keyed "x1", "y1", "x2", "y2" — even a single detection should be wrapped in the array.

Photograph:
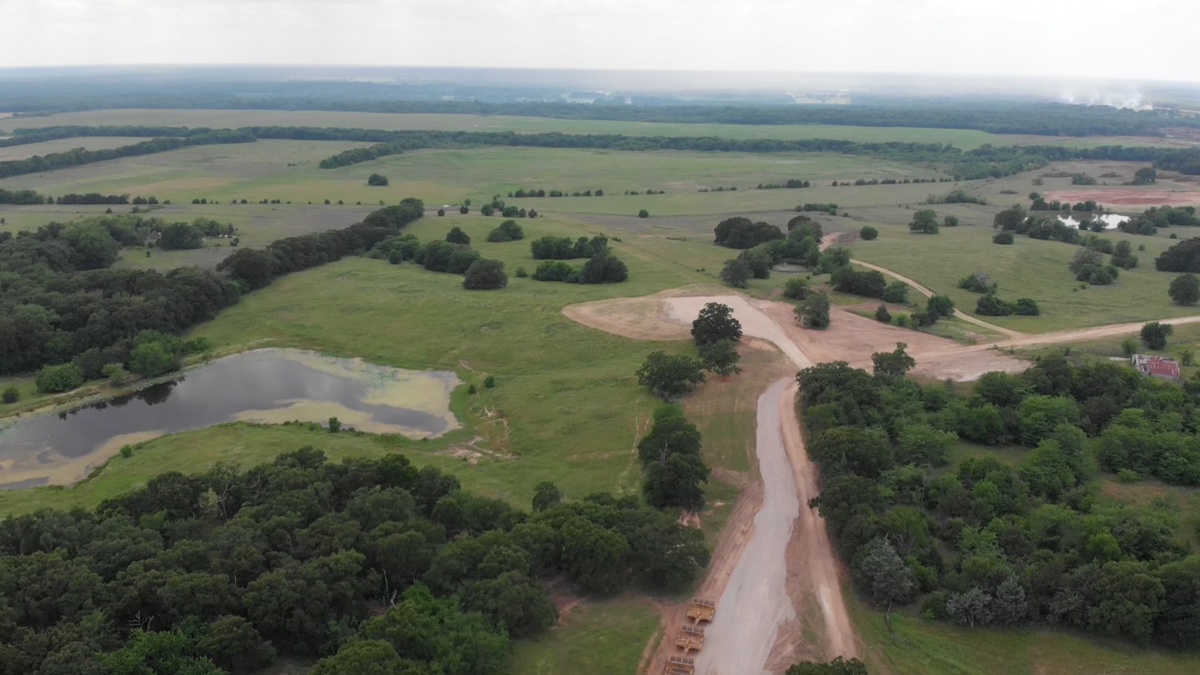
[{"x1": 0, "y1": 350, "x2": 460, "y2": 489}]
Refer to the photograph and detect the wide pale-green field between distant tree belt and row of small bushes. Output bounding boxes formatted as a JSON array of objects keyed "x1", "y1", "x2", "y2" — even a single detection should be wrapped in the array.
[{"x1": 0, "y1": 141, "x2": 938, "y2": 216}]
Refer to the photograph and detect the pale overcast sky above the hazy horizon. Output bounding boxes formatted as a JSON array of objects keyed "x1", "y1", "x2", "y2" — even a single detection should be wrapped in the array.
[{"x1": 0, "y1": 0, "x2": 1200, "y2": 82}]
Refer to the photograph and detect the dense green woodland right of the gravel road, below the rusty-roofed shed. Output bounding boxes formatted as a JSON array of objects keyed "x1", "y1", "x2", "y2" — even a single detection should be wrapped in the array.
[{"x1": 798, "y1": 350, "x2": 1200, "y2": 647}]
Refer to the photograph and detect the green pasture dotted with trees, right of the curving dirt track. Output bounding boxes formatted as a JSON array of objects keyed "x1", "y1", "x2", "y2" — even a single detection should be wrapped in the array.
[{"x1": 852, "y1": 214, "x2": 1195, "y2": 333}]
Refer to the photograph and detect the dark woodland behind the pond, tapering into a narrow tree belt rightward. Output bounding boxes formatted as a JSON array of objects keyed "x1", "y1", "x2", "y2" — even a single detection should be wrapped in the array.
[{"x1": 0, "y1": 199, "x2": 425, "y2": 378}]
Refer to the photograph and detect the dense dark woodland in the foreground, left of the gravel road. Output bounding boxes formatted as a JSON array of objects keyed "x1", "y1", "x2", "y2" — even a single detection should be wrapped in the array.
[{"x1": 0, "y1": 448, "x2": 708, "y2": 675}]
